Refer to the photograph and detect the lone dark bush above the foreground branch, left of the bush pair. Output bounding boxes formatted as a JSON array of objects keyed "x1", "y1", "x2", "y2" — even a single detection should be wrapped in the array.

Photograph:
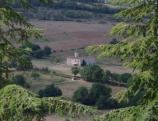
[{"x1": 39, "y1": 84, "x2": 62, "y2": 98}]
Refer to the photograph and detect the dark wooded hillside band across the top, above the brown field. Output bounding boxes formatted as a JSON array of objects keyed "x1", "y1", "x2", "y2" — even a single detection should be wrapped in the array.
[{"x1": 22, "y1": 0, "x2": 120, "y2": 22}]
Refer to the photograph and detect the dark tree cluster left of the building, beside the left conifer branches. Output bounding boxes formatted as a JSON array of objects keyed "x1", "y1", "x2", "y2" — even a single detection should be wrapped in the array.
[{"x1": 9, "y1": 43, "x2": 52, "y2": 71}]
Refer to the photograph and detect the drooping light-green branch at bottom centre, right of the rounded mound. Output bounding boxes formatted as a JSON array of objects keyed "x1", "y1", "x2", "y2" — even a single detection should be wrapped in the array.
[{"x1": 42, "y1": 97, "x2": 96, "y2": 117}]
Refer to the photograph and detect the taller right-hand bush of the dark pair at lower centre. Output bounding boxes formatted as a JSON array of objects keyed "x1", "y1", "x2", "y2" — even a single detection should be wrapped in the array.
[{"x1": 90, "y1": 83, "x2": 112, "y2": 104}]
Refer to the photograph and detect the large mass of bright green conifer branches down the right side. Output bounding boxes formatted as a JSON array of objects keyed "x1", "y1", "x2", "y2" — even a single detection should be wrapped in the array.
[{"x1": 89, "y1": 0, "x2": 158, "y2": 103}]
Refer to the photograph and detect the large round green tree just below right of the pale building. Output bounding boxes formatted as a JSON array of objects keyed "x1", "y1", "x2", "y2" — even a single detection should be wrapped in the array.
[{"x1": 80, "y1": 65, "x2": 104, "y2": 82}]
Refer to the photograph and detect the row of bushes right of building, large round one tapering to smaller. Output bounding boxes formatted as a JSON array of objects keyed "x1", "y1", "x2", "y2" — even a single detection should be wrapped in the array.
[{"x1": 80, "y1": 65, "x2": 132, "y2": 83}]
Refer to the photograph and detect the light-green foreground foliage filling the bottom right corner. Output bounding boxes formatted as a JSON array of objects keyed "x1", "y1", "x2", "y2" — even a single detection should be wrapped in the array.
[{"x1": 93, "y1": 96, "x2": 158, "y2": 121}]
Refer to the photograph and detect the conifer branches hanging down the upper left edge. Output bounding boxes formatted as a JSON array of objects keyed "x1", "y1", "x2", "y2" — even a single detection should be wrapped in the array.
[{"x1": 0, "y1": 0, "x2": 45, "y2": 80}]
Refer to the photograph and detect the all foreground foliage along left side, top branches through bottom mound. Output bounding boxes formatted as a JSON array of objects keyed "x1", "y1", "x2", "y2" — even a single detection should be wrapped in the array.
[{"x1": 0, "y1": 0, "x2": 93, "y2": 121}]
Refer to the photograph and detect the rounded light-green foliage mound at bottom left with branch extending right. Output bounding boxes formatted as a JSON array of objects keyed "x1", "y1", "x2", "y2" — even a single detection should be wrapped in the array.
[{"x1": 0, "y1": 85, "x2": 95, "y2": 121}]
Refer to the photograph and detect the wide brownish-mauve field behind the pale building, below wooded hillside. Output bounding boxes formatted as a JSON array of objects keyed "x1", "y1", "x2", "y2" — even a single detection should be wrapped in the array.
[{"x1": 31, "y1": 20, "x2": 118, "y2": 50}]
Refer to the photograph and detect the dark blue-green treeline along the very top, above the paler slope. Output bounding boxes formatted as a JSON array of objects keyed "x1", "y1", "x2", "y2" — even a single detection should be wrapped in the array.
[{"x1": 14, "y1": 0, "x2": 121, "y2": 14}]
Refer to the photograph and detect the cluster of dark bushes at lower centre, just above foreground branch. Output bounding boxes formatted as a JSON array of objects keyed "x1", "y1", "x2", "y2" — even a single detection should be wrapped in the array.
[{"x1": 72, "y1": 83, "x2": 117, "y2": 109}]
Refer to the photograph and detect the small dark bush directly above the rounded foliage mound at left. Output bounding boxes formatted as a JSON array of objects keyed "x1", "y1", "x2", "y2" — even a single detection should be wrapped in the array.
[{"x1": 13, "y1": 75, "x2": 30, "y2": 88}]
